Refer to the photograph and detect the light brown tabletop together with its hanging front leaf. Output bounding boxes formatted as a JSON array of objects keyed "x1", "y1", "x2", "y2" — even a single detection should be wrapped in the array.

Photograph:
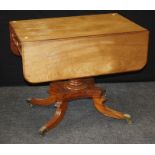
[{"x1": 10, "y1": 14, "x2": 149, "y2": 83}]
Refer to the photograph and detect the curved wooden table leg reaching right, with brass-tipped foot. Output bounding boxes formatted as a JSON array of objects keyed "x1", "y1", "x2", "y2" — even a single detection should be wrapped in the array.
[{"x1": 93, "y1": 96, "x2": 131, "y2": 123}]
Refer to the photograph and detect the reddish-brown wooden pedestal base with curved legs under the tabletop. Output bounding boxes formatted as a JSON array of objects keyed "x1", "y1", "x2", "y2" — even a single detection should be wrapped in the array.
[{"x1": 28, "y1": 78, "x2": 131, "y2": 135}]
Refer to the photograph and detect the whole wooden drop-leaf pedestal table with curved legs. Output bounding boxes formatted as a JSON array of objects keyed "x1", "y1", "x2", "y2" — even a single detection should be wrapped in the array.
[{"x1": 10, "y1": 13, "x2": 149, "y2": 134}]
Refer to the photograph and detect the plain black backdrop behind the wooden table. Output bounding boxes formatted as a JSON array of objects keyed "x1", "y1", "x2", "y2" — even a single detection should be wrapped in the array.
[{"x1": 0, "y1": 10, "x2": 155, "y2": 86}]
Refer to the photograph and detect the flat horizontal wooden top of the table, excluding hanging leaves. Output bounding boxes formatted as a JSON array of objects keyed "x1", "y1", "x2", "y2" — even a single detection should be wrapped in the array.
[{"x1": 10, "y1": 13, "x2": 145, "y2": 42}]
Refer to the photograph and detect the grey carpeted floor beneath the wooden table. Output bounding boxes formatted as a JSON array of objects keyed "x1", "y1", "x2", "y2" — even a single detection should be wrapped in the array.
[{"x1": 0, "y1": 82, "x2": 155, "y2": 144}]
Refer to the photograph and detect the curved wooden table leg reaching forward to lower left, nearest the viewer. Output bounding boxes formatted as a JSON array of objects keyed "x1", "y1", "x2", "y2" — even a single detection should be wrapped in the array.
[{"x1": 39, "y1": 102, "x2": 68, "y2": 135}]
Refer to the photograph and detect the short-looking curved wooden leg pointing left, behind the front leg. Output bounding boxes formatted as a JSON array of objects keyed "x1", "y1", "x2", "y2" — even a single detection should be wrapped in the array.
[{"x1": 27, "y1": 96, "x2": 56, "y2": 106}]
